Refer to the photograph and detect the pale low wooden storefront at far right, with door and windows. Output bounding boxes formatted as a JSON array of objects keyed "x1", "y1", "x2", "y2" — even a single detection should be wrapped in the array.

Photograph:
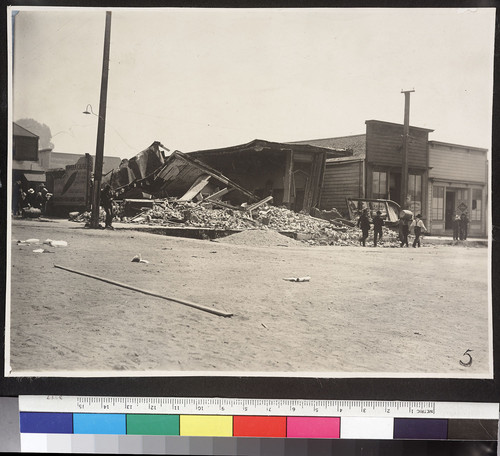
[{"x1": 427, "y1": 141, "x2": 488, "y2": 236}]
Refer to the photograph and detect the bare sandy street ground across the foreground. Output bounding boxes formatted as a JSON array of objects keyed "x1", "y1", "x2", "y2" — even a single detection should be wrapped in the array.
[{"x1": 10, "y1": 220, "x2": 490, "y2": 376}]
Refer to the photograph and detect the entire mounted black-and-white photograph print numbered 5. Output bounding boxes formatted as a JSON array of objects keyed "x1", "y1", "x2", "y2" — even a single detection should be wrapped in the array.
[{"x1": 2, "y1": 6, "x2": 495, "y2": 379}]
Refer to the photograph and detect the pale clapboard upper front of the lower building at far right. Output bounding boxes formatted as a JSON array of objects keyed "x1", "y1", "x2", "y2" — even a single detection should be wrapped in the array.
[{"x1": 429, "y1": 144, "x2": 486, "y2": 182}]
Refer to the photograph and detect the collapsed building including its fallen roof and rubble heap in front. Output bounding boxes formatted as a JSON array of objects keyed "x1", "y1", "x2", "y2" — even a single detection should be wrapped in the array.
[{"x1": 85, "y1": 140, "x2": 402, "y2": 245}]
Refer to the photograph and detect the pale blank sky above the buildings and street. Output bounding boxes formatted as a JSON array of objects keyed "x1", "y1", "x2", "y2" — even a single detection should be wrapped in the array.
[{"x1": 9, "y1": 7, "x2": 495, "y2": 158}]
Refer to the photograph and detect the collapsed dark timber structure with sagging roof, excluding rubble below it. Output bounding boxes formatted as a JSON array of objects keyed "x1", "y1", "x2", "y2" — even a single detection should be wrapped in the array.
[{"x1": 103, "y1": 139, "x2": 351, "y2": 213}]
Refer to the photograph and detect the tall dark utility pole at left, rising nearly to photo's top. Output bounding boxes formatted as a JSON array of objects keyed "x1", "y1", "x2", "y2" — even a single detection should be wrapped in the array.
[{"x1": 90, "y1": 11, "x2": 111, "y2": 228}]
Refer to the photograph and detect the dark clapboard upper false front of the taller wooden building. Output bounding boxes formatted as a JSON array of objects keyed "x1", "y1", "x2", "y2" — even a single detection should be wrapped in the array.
[{"x1": 366, "y1": 122, "x2": 428, "y2": 168}]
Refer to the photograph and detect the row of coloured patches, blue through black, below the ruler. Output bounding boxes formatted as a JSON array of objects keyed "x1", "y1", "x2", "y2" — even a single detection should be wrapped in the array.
[{"x1": 20, "y1": 412, "x2": 498, "y2": 440}]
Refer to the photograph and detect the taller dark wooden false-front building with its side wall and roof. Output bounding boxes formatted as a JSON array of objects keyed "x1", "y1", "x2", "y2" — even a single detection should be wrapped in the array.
[{"x1": 292, "y1": 120, "x2": 433, "y2": 219}]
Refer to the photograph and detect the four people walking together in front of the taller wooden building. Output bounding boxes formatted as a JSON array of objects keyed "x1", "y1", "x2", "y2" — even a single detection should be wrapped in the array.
[{"x1": 357, "y1": 208, "x2": 427, "y2": 247}]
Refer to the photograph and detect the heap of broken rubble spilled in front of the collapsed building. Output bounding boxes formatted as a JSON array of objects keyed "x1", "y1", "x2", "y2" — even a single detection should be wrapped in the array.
[{"x1": 111, "y1": 199, "x2": 398, "y2": 246}]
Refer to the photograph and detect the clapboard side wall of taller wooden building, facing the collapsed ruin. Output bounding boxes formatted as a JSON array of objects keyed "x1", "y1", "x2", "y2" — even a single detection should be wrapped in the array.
[{"x1": 320, "y1": 160, "x2": 364, "y2": 212}]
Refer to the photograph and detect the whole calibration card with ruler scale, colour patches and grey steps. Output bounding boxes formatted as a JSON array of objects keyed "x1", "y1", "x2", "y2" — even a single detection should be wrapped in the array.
[{"x1": 19, "y1": 396, "x2": 499, "y2": 454}]
